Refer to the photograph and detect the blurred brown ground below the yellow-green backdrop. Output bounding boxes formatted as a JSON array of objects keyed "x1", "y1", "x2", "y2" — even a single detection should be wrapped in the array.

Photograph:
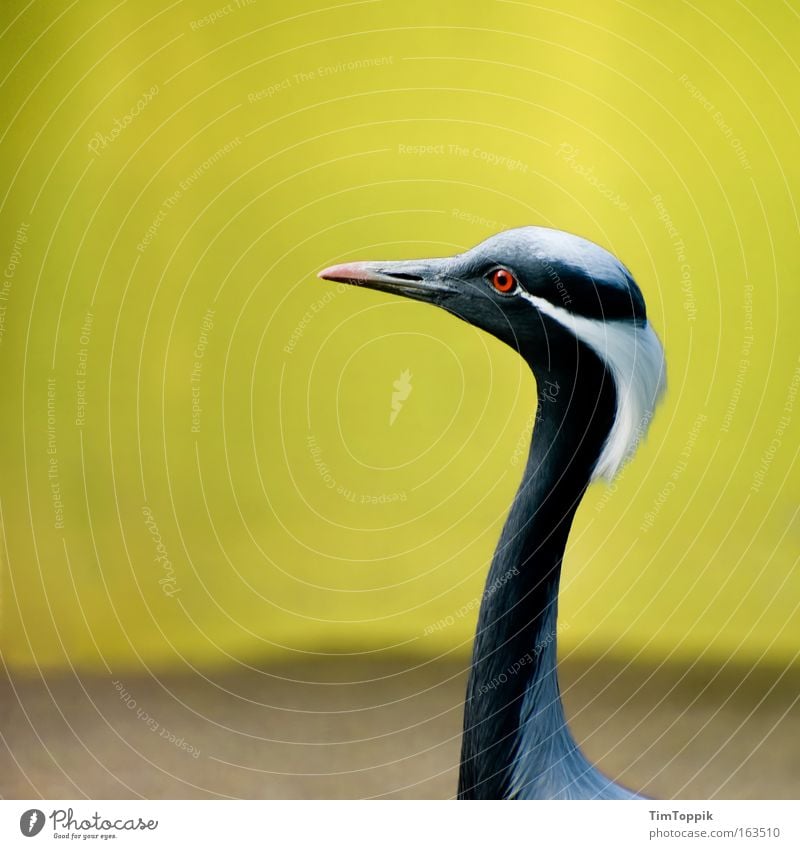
[{"x1": 0, "y1": 661, "x2": 800, "y2": 799}]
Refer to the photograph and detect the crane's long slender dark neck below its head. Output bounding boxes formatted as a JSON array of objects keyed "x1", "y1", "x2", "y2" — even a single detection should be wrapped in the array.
[{"x1": 459, "y1": 344, "x2": 615, "y2": 799}]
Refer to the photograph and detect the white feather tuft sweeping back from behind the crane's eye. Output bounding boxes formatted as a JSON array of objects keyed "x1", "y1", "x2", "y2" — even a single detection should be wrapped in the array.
[{"x1": 520, "y1": 292, "x2": 666, "y2": 481}]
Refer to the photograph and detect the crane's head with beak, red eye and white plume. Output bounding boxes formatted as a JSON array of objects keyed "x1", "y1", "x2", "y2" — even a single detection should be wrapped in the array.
[{"x1": 319, "y1": 227, "x2": 665, "y2": 480}]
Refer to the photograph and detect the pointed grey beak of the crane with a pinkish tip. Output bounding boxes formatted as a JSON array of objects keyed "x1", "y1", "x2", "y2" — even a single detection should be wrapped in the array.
[{"x1": 318, "y1": 259, "x2": 459, "y2": 304}]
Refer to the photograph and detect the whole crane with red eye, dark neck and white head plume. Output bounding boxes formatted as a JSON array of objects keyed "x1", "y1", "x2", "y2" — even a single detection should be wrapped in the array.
[{"x1": 318, "y1": 226, "x2": 666, "y2": 799}]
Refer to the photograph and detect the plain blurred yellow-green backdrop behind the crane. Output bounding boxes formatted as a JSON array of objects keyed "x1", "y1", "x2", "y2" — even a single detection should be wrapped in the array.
[{"x1": 0, "y1": 0, "x2": 800, "y2": 669}]
